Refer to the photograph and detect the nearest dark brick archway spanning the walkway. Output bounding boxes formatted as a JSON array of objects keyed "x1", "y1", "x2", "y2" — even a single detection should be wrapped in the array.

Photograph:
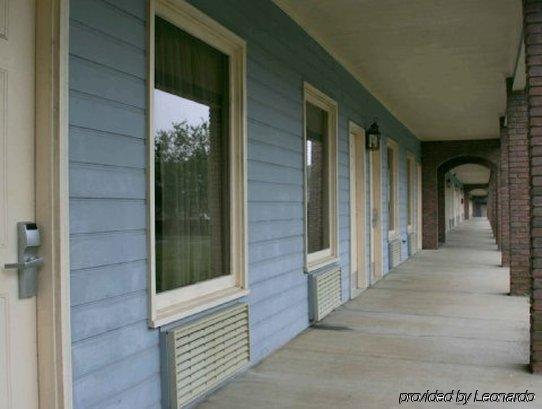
[{"x1": 422, "y1": 139, "x2": 500, "y2": 249}]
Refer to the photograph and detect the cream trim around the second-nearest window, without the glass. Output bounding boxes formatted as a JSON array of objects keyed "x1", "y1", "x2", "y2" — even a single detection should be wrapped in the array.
[{"x1": 303, "y1": 82, "x2": 339, "y2": 272}]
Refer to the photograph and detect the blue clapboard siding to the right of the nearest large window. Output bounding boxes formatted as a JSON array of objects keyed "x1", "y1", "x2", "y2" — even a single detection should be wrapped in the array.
[{"x1": 190, "y1": 0, "x2": 419, "y2": 361}]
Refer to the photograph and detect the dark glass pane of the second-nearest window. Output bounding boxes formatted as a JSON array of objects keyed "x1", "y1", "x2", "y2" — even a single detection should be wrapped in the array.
[{"x1": 305, "y1": 102, "x2": 330, "y2": 254}]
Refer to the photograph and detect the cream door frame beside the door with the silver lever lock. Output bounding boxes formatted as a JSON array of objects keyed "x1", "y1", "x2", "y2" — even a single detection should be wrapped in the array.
[{"x1": 35, "y1": 0, "x2": 72, "y2": 409}]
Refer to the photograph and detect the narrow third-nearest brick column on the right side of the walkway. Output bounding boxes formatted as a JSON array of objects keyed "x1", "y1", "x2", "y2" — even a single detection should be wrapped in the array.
[{"x1": 499, "y1": 118, "x2": 510, "y2": 267}]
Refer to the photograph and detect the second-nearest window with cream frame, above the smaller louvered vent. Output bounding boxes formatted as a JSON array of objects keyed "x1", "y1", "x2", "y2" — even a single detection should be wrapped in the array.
[{"x1": 305, "y1": 84, "x2": 337, "y2": 270}]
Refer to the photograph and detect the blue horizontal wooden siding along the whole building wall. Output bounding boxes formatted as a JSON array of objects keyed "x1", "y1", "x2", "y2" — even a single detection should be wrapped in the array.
[{"x1": 70, "y1": 0, "x2": 419, "y2": 408}]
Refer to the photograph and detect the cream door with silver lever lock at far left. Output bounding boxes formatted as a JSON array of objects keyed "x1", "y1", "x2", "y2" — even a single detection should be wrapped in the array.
[{"x1": 0, "y1": 0, "x2": 38, "y2": 409}]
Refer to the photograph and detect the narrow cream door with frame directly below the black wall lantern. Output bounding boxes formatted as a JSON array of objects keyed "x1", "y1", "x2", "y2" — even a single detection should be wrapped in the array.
[{"x1": 369, "y1": 149, "x2": 384, "y2": 285}]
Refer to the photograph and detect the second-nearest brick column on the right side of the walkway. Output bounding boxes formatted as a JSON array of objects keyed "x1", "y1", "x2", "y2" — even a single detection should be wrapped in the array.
[{"x1": 507, "y1": 91, "x2": 530, "y2": 295}]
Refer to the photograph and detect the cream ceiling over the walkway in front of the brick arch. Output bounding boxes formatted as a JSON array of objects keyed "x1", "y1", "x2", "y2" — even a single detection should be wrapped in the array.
[{"x1": 275, "y1": 0, "x2": 522, "y2": 140}]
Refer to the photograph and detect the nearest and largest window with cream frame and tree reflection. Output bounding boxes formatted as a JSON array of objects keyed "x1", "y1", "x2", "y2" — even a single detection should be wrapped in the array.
[{"x1": 149, "y1": 1, "x2": 246, "y2": 325}]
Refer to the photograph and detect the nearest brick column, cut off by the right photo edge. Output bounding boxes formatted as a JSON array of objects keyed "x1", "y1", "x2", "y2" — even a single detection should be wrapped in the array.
[{"x1": 524, "y1": 0, "x2": 542, "y2": 373}]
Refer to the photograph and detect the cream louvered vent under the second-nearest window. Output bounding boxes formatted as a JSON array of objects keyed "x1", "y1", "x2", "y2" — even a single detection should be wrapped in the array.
[{"x1": 309, "y1": 268, "x2": 341, "y2": 321}]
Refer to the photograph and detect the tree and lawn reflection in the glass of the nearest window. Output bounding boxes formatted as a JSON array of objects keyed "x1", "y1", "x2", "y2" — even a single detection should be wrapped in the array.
[{"x1": 154, "y1": 121, "x2": 216, "y2": 289}]
